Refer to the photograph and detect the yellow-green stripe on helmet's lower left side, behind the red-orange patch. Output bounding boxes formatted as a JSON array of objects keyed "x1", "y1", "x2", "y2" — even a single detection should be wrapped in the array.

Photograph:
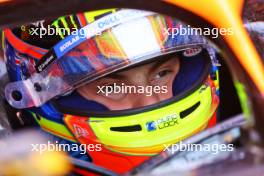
[{"x1": 32, "y1": 113, "x2": 76, "y2": 142}]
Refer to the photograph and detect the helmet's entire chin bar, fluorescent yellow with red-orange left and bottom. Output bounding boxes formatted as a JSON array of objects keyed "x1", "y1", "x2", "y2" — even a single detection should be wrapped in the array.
[{"x1": 63, "y1": 80, "x2": 219, "y2": 174}]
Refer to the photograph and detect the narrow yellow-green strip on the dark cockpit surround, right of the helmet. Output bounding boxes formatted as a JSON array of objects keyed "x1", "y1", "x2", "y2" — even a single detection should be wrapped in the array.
[{"x1": 234, "y1": 81, "x2": 252, "y2": 122}]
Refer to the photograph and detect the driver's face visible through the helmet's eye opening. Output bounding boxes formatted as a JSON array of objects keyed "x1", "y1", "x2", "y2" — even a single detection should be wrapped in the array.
[{"x1": 77, "y1": 56, "x2": 180, "y2": 110}]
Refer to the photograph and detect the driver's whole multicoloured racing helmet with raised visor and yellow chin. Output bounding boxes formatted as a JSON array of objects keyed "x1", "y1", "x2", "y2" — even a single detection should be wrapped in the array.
[{"x1": 3, "y1": 9, "x2": 219, "y2": 173}]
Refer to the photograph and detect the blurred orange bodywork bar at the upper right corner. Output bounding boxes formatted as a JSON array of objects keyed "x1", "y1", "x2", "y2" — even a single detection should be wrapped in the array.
[{"x1": 165, "y1": 0, "x2": 264, "y2": 97}]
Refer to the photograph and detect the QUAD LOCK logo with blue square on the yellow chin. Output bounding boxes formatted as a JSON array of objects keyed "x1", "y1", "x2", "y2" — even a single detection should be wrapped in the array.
[{"x1": 146, "y1": 114, "x2": 179, "y2": 131}]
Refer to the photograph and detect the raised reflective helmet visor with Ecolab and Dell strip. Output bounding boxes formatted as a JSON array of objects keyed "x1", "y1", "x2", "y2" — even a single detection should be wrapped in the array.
[{"x1": 5, "y1": 10, "x2": 206, "y2": 108}]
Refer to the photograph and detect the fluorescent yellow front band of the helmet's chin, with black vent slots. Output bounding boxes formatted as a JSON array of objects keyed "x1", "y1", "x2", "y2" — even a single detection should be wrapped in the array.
[{"x1": 88, "y1": 85, "x2": 218, "y2": 155}]
